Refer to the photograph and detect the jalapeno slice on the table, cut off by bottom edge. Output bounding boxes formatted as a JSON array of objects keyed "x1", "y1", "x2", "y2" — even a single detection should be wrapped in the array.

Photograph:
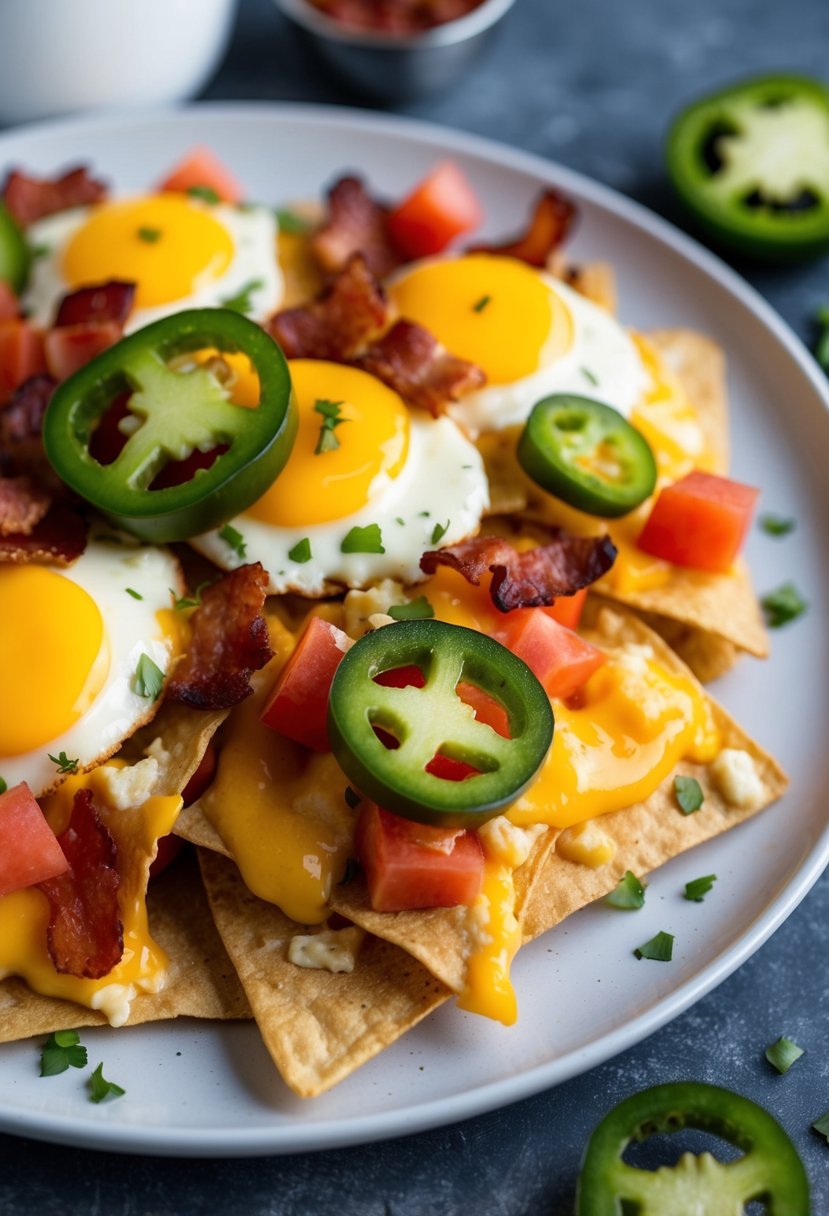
[{"x1": 576, "y1": 1081, "x2": 811, "y2": 1216}]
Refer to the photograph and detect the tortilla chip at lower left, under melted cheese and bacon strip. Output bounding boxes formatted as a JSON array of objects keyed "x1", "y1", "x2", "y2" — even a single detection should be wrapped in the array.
[{"x1": 0, "y1": 857, "x2": 250, "y2": 1042}]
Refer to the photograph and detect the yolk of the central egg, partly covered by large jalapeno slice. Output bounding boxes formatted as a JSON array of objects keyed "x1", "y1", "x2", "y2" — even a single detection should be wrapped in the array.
[{"x1": 246, "y1": 359, "x2": 408, "y2": 528}]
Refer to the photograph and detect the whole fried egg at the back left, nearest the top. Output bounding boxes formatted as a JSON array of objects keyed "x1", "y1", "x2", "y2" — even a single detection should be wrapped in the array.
[{"x1": 23, "y1": 193, "x2": 282, "y2": 332}]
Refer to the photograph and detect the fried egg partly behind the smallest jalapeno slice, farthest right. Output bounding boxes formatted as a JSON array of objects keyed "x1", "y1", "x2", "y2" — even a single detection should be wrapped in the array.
[{"x1": 388, "y1": 253, "x2": 648, "y2": 437}]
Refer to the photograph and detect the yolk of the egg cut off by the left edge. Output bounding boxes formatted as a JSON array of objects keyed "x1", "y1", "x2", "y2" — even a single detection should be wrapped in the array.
[{"x1": 0, "y1": 565, "x2": 109, "y2": 756}]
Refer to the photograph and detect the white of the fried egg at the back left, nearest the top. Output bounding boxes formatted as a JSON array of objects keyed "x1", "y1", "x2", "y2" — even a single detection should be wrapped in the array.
[{"x1": 23, "y1": 199, "x2": 283, "y2": 333}]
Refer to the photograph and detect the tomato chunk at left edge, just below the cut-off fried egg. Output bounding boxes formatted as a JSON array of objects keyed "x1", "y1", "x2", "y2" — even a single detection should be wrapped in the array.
[{"x1": 0, "y1": 782, "x2": 69, "y2": 895}]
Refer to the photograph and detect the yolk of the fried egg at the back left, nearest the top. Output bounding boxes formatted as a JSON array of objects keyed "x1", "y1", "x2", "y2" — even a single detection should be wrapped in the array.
[{"x1": 62, "y1": 195, "x2": 233, "y2": 308}]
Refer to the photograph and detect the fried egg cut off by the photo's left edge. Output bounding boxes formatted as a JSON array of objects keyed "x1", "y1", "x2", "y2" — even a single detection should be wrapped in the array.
[{"x1": 0, "y1": 540, "x2": 181, "y2": 796}]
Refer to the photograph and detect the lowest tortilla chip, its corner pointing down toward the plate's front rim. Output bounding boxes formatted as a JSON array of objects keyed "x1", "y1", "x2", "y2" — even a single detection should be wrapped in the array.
[{"x1": 199, "y1": 851, "x2": 450, "y2": 1098}]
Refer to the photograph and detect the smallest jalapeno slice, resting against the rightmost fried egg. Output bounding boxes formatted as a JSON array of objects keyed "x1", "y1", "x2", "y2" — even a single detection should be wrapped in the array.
[{"x1": 518, "y1": 393, "x2": 656, "y2": 519}]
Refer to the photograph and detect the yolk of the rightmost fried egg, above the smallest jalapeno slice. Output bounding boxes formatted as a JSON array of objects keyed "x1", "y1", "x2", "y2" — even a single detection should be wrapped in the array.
[{"x1": 389, "y1": 253, "x2": 573, "y2": 384}]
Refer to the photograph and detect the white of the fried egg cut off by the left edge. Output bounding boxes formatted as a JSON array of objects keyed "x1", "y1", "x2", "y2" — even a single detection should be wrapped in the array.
[{"x1": 0, "y1": 539, "x2": 182, "y2": 798}]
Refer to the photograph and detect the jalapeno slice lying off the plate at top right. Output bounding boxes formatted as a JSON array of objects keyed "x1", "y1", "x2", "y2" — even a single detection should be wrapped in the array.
[{"x1": 666, "y1": 75, "x2": 829, "y2": 260}]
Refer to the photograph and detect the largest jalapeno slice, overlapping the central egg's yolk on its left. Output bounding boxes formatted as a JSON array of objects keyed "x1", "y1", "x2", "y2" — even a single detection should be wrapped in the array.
[{"x1": 44, "y1": 309, "x2": 297, "y2": 544}]
